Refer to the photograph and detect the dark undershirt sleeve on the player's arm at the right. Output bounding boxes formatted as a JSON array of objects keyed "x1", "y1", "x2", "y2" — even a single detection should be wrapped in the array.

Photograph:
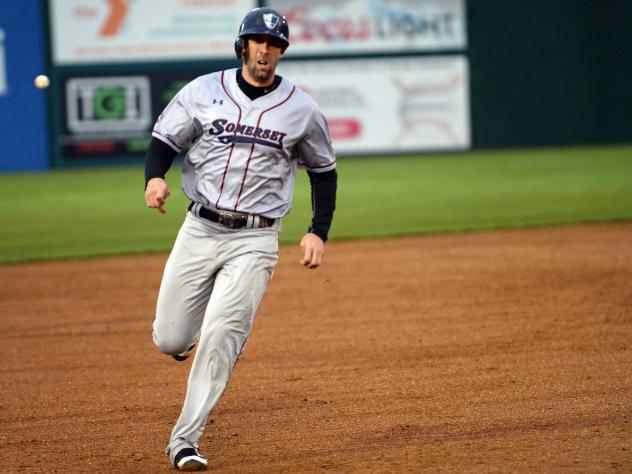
[{"x1": 307, "y1": 169, "x2": 338, "y2": 242}]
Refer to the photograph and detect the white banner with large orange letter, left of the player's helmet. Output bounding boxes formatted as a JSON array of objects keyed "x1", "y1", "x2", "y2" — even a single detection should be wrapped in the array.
[{"x1": 50, "y1": 0, "x2": 257, "y2": 64}]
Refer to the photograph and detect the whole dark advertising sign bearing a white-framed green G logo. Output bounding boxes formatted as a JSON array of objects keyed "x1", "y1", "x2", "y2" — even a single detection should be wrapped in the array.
[{"x1": 55, "y1": 69, "x2": 209, "y2": 161}]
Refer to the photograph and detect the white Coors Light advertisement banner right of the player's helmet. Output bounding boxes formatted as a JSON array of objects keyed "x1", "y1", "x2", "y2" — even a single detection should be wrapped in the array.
[{"x1": 268, "y1": 0, "x2": 467, "y2": 56}]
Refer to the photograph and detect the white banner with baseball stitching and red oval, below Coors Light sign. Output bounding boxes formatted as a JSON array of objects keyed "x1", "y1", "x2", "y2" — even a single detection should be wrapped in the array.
[{"x1": 278, "y1": 56, "x2": 471, "y2": 154}]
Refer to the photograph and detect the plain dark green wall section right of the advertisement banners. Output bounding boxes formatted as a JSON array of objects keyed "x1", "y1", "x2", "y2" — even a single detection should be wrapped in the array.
[{"x1": 468, "y1": 0, "x2": 632, "y2": 149}]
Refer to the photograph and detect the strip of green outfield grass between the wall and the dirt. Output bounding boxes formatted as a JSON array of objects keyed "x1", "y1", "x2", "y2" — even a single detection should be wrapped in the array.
[{"x1": 0, "y1": 146, "x2": 632, "y2": 262}]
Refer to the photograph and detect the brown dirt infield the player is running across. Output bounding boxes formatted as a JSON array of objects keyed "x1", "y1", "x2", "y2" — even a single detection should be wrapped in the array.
[{"x1": 0, "y1": 223, "x2": 632, "y2": 473}]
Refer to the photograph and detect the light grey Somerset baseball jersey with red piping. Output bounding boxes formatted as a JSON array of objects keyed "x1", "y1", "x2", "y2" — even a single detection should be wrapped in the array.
[{"x1": 152, "y1": 69, "x2": 336, "y2": 218}]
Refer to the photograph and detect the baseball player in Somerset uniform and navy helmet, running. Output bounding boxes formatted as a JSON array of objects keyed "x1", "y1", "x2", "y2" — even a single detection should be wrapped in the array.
[{"x1": 145, "y1": 8, "x2": 337, "y2": 470}]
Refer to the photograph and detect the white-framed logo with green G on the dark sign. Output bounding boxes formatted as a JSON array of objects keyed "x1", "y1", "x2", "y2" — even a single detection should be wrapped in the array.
[{"x1": 66, "y1": 76, "x2": 152, "y2": 134}]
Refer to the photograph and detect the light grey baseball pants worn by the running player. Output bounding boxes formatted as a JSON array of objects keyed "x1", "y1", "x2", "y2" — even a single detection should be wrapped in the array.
[{"x1": 153, "y1": 213, "x2": 280, "y2": 463}]
